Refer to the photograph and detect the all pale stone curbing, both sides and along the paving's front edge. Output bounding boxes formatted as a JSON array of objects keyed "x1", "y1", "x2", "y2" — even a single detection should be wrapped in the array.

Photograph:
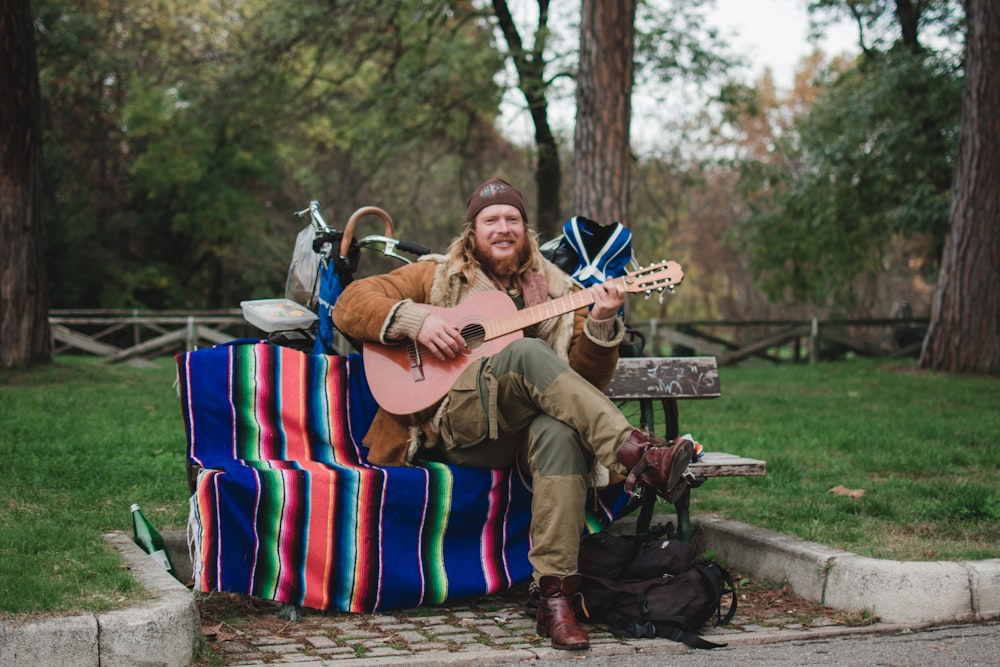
[{"x1": 0, "y1": 516, "x2": 1000, "y2": 667}]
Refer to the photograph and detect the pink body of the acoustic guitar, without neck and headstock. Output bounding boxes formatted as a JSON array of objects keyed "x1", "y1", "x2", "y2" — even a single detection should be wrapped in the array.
[{"x1": 362, "y1": 291, "x2": 524, "y2": 415}]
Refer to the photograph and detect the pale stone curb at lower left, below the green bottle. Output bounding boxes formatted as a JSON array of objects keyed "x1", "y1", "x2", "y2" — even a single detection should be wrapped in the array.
[{"x1": 0, "y1": 533, "x2": 201, "y2": 667}]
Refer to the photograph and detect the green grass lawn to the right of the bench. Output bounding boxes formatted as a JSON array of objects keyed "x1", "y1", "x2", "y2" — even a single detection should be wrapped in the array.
[{"x1": 680, "y1": 360, "x2": 1000, "y2": 560}]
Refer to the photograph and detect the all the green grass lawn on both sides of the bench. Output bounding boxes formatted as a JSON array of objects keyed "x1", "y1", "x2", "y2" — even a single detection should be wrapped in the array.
[{"x1": 0, "y1": 356, "x2": 1000, "y2": 617}]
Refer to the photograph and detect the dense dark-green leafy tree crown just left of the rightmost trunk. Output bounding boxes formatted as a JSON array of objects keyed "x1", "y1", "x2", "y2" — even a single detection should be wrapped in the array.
[{"x1": 736, "y1": 49, "x2": 961, "y2": 305}]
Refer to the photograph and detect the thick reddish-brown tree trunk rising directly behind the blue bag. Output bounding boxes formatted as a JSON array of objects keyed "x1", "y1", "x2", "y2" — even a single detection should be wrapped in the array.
[{"x1": 572, "y1": 0, "x2": 635, "y2": 223}]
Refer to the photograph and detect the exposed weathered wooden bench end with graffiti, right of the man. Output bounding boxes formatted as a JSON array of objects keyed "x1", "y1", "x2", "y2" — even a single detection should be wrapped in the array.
[{"x1": 604, "y1": 357, "x2": 766, "y2": 541}]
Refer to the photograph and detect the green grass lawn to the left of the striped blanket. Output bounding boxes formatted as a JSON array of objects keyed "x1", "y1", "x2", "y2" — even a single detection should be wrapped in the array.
[{"x1": 0, "y1": 356, "x2": 187, "y2": 615}]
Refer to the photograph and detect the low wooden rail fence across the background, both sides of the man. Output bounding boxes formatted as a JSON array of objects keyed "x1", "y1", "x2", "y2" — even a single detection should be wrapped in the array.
[{"x1": 49, "y1": 309, "x2": 928, "y2": 366}]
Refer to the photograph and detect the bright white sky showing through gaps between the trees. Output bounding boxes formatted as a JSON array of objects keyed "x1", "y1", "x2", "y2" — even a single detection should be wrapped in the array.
[{"x1": 500, "y1": 0, "x2": 858, "y2": 143}]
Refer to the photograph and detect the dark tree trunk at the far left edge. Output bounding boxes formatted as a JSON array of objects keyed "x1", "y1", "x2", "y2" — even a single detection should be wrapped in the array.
[{"x1": 0, "y1": 0, "x2": 52, "y2": 368}]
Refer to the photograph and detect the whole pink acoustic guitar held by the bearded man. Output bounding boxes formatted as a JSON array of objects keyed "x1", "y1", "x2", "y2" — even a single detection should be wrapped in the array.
[{"x1": 362, "y1": 261, "x2": 684, "y2": 415}]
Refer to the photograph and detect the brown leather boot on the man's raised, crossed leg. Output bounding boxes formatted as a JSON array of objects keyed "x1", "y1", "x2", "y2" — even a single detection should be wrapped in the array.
[{"x1": 617, "y1": 429, "x2": 694, "y2": 503}]
